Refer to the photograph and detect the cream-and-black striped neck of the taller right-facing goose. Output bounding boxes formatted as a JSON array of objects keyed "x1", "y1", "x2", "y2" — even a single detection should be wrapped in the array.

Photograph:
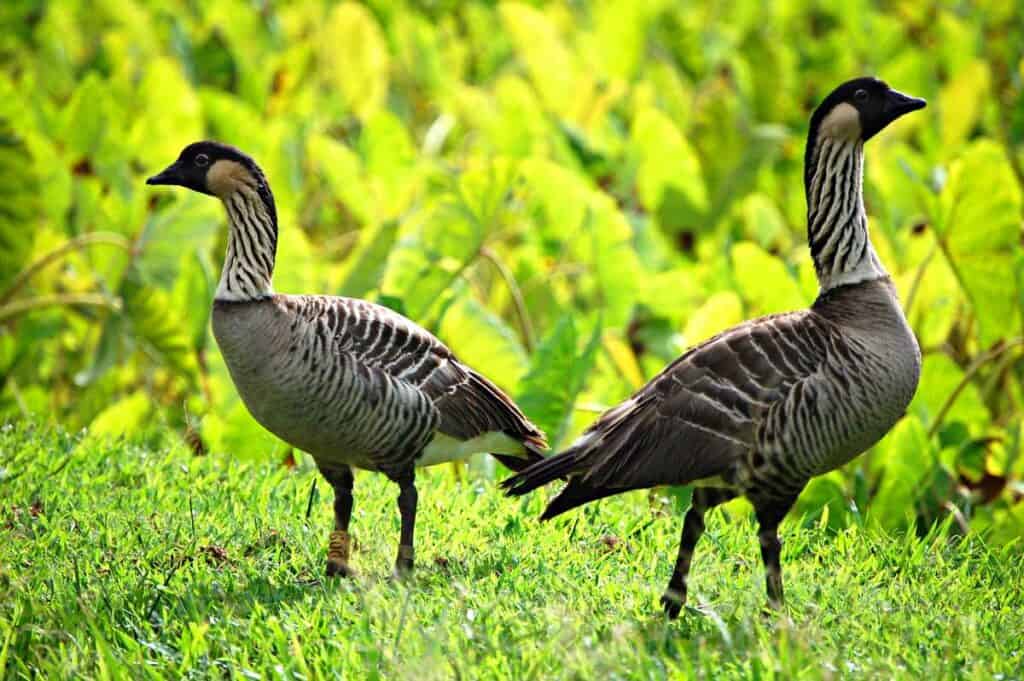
[{"x1": 805, "y1": 134, "x2": 888, "y2": 293}]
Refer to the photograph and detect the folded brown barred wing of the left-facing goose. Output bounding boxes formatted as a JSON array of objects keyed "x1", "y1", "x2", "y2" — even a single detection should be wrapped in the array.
[{"x1": 303, "y1": 297, "x2": 546, "y2": 449}]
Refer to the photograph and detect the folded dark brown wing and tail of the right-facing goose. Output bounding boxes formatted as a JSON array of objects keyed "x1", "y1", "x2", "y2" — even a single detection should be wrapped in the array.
[{"x1": 506, "y1": 311, "x2": 837, "y2": 503}]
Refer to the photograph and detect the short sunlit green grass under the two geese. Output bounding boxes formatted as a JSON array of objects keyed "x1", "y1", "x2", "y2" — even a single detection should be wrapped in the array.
[{"x1": 0, "y1": 426, "x2": 1024, "y2": 679}]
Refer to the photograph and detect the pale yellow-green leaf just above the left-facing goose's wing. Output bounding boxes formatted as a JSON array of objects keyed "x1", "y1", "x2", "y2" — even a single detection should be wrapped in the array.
[{"x1": 438, "y1": 294, "x2": 529, "y2": 393}]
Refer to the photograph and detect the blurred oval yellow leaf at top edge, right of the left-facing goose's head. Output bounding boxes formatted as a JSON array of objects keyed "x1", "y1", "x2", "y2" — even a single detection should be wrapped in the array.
[{"x1": 317, "y1": 2, "x2": 390, "y2": 118}]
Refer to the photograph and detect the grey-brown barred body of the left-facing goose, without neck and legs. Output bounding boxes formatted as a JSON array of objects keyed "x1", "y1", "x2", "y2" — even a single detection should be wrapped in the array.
[{"x1": 212, "y1": 295, "x2": 544, "y2": 473}]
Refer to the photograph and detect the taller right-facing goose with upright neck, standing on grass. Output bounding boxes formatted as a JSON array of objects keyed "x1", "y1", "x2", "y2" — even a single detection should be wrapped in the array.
[{"x1": 503, "y1": 78, "x2": 925, "y2": 618}]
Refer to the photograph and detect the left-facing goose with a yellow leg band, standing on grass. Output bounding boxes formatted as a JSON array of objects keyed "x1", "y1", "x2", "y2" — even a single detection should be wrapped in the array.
[{"x1": 146, "y1": 141, "x2": 547, "y2": 577}]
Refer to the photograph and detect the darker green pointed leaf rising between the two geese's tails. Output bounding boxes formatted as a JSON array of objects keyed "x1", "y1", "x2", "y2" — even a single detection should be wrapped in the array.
[{"x1": 516, "y1": 314, "x2": 601, "y2": 449}]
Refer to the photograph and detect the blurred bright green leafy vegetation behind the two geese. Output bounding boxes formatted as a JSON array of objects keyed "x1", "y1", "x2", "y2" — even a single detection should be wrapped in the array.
[{"x1": 0, "y1": 0, "x2": 1024, "y2": 542}]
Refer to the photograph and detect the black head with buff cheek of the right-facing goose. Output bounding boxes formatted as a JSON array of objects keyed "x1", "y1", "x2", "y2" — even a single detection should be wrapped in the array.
[{"x1": 811, "y1": 78, "x2": 926, "y2": 142}]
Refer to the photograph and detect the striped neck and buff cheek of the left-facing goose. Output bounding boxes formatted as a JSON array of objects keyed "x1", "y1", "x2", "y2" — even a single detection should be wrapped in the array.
[{"x1": 208, "y1": 161, "x2": 278, "y2": 302}]
